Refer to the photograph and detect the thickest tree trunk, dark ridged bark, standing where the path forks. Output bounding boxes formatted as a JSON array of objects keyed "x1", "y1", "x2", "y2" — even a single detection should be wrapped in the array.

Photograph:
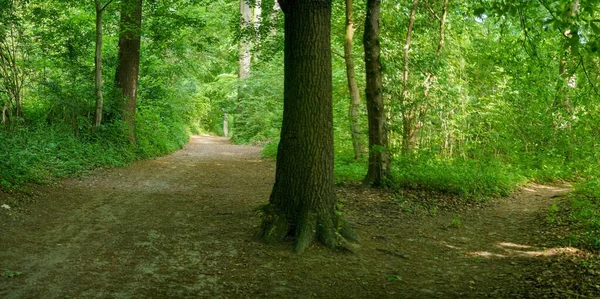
[{"x1": 260, "y1": 0, "x2": 357, "y2": 253}]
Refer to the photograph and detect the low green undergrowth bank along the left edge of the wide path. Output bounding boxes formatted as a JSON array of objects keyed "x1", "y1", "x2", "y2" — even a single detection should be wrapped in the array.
[{"x1": 0, "y1": 115, "x2": 188, "y2": 190}]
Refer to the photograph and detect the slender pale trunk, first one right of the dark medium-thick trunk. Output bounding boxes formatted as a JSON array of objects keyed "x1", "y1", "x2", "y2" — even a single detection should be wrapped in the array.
[{"x1": 402, "y1": 0, "x2": 422, "y2": 153}]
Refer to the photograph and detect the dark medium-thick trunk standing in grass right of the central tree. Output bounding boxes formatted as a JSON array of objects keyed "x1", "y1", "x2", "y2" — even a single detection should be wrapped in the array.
[{"x1": 363, "y1": 0, "x2": 390, "y2": 187}]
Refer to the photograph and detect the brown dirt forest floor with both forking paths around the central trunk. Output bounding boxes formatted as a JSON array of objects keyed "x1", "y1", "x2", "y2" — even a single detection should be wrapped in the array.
[{"x1": 0, "y1": 136, "x2": 600, "y2": 298}]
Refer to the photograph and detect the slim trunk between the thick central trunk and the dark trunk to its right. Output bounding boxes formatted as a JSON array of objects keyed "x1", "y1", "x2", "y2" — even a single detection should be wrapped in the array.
[{"x1": 344, "y1": 0, "x2": 365, "y2": 159}]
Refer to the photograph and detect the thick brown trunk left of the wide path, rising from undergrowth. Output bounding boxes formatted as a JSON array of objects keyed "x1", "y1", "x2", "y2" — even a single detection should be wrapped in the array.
[{"x1": 115, "y1": 0, "x2": 142, "y2": 143}]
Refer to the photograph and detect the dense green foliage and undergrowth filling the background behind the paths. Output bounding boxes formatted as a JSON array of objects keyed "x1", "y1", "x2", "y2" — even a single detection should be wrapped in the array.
[{"x1": 0, "y1": 0, "x2": 600, "y2": 246}]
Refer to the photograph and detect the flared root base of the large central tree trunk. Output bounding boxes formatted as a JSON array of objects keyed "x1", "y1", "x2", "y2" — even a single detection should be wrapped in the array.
[{"x1": 259, "y1": 204, "x2": 360, "y2": 253}]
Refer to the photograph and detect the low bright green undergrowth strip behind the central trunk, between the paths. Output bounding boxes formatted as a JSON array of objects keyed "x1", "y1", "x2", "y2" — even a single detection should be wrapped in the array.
[{"x1": 262, "y1": 141, "x2": 528, "y2": 200}]
